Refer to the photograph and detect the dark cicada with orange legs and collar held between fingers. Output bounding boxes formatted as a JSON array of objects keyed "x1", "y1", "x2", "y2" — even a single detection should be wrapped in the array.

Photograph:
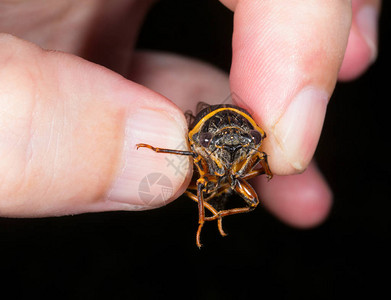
[{"x1": 137, "y1": 103, "x2": 273, "y2": 248}]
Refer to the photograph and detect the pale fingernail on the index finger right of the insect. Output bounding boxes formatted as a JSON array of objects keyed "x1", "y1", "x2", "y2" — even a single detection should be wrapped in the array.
[{"x1": 273, "y1": 86, "x2": 329, "y2": 172}]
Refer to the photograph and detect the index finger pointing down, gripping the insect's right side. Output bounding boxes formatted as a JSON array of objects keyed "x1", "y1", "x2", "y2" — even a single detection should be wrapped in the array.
[{"x1": 230, "y1": 0, "x2": 351, "y2": 174}]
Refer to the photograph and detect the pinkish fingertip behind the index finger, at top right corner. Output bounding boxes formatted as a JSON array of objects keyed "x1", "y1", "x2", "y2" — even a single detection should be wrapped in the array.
[{"x1": 338, "y1": 0, "x2": 380, "y2": 80}]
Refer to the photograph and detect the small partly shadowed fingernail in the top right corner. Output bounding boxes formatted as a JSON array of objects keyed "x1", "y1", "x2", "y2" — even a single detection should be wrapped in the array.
[{"x1": 356, "y1": 5, "x2": 378, "y2": 62}]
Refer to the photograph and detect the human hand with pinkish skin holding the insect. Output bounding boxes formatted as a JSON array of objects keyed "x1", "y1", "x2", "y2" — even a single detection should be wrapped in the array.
[{"x1": 0, "y1": 0, "x2": 380, "y2": 227}]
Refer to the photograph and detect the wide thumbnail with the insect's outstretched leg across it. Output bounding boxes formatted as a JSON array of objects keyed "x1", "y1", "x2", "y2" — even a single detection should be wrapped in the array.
[{"x1": 108, "y1": 108, "x2": 190, "y2": 210}]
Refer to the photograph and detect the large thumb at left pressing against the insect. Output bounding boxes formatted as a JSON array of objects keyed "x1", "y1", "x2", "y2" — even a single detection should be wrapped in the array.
[{"x1": 0, "y1": 35, "x2": 191, "y2": 217}]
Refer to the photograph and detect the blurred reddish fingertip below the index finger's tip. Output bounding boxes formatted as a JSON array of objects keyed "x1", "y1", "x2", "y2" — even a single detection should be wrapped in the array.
[{"x1": 257, "y1": 163, "x2": 332, "y2": 228}]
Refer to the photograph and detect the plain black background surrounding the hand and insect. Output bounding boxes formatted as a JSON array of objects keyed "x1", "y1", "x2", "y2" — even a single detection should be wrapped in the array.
[{"x1": 0, "y1": 0, "x2": 391, "y2": 299}]
